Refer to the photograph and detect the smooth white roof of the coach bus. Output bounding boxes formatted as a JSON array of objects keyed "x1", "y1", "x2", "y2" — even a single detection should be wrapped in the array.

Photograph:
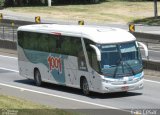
[{"x1": 18, "y1": 24, "x2": 136, "y2": 44}]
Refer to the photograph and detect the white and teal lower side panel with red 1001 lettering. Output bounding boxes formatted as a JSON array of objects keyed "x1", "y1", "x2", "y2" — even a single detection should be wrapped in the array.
[{"x1": 18, "y1": 47, "x2": 80, "y2": 88}]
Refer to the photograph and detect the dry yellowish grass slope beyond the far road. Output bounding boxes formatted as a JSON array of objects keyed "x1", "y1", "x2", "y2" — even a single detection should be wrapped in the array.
[{"x1": 4, "y1": 0, "x2": 160, "y2": 25}]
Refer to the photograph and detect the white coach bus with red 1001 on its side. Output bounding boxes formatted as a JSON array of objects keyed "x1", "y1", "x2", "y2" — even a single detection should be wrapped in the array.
[{"x1": 17, "y1": 24, "x2": 148, "y2": 95}]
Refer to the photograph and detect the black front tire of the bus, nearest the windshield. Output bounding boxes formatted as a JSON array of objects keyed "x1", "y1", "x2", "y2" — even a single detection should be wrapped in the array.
[{"x1": 82, "y1": 78, "x2": 90, "y2": 96}]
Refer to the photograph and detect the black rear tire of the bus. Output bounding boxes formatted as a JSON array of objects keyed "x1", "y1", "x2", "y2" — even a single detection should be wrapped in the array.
[{"x1": 34, "y1": 70, "x2": 42, "y2": 86}]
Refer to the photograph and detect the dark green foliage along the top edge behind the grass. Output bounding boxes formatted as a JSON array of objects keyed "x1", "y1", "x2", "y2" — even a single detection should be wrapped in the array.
[{"x1": 0, "y1": 0, "x2": 160, "y2": 7}]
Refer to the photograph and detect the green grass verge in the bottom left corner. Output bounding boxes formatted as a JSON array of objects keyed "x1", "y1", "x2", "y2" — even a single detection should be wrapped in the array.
[{"x1": 0, "y1": 95, "x2": 75, "y2": 115}]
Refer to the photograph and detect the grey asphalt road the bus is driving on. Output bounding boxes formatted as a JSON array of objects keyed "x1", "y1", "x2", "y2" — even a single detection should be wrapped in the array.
[{"x1": 0, "y1": 55, "x2": 160, "y2": 115}]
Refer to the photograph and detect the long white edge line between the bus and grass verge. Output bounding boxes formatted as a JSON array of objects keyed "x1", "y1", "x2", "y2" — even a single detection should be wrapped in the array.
[{"x1": 0, "y1": 83, "x2": 130, "y2": 112}]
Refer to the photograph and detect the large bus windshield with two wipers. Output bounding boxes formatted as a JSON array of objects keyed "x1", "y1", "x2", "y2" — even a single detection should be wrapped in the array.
[{"x1": 98, "y1": 41, "x2": 143, "y2": 78}]
